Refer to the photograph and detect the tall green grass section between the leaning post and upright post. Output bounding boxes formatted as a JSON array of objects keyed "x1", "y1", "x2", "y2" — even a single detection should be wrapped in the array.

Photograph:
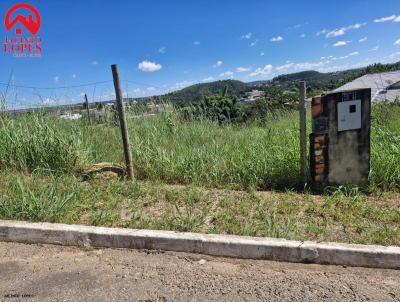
[{"x1": 126, "y1": 113, "x2": 301, "y2": 189}]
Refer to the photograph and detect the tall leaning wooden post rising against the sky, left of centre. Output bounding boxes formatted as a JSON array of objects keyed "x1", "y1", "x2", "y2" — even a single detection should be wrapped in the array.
[{"x1": 111, "y1": 64, "x2": 134, "y2": 180}]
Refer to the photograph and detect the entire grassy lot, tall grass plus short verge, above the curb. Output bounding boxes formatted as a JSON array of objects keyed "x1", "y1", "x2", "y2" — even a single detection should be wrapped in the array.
[{"x1": 0, "y1": 104, "x2": 400, "y2": 245}]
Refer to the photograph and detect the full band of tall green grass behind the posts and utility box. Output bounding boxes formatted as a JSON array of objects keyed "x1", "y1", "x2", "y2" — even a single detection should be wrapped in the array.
[{"x1": 0, "y1": 104, "x2": 400, "y2": 191}]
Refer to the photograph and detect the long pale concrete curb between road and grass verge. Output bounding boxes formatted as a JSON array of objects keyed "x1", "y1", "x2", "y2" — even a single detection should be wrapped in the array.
[{"x1": 0, "y1": 220, "x2": 400, "y2": 269}]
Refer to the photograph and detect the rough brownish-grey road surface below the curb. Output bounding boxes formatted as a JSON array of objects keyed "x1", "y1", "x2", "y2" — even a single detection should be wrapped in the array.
[{"x1": 0, "y1": 243, "x2": 400, "y2": 302}]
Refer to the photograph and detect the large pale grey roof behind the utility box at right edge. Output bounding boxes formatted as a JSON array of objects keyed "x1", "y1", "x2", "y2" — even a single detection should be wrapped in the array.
[{"x1": 334, "y1": 71, "x2": 400, "y2": 102}]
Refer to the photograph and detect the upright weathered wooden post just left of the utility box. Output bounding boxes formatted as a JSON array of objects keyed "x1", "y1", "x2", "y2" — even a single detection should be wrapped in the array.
[{"x1": 299, "y1": 81, "x2": 307, "y2": 184}]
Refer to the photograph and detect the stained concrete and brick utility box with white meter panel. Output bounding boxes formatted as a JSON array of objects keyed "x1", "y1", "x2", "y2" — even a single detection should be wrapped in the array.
[{"x1": 310, "y1": 89, "x2": 371, "y2": 186}]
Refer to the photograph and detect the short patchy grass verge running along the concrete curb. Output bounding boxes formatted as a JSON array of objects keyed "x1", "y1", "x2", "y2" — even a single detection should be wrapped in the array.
[{"x1": 0, "y1": 171, "x2": 400, "y2": 245}]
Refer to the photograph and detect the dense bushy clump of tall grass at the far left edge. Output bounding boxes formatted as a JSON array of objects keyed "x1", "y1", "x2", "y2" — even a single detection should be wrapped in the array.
[{"x1": 0, "y1": 114, "x2": 85, "y2": 172}]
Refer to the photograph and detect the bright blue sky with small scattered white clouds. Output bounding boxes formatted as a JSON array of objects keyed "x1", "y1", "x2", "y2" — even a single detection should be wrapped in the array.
[{"x1": 0, "y1": 0, "x2": 400, "y2": 107}]
